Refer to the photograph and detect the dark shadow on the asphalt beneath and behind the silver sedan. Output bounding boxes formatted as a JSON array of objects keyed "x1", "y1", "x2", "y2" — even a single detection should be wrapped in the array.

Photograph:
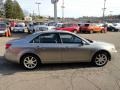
[{"x1": 0, "y1": 56, "x2": 95, "y2": 75}]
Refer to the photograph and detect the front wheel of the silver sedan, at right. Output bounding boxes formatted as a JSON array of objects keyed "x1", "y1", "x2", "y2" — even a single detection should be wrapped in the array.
[{"x1": 92, "y1": 52, "x2": 109, "y2": 67}]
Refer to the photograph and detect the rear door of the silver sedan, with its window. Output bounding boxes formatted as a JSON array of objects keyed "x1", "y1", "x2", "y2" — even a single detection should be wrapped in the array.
[{"x1": 31, "y1": 33, "x2": 61, "y2": 63}]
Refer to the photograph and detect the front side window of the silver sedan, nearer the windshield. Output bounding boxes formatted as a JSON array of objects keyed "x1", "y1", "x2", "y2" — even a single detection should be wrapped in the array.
[{"x1": 60, "y1": 33, "x2": 82, "y2": 44}]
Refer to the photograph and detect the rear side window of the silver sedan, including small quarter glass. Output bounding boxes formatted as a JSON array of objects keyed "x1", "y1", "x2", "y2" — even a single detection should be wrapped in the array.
[{"x1": 32, "y1": 33, "x2": 60, "y2": 43}]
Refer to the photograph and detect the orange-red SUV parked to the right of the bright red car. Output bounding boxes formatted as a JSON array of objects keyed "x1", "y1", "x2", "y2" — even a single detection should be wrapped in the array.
[{"x1": 80, "y1": 23, "x2": 107, "y2": 34}]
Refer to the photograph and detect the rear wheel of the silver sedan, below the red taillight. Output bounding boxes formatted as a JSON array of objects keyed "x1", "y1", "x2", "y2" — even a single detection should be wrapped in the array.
[{"x1": 21, "y1": 54, "x2": 39, "y2": 70}]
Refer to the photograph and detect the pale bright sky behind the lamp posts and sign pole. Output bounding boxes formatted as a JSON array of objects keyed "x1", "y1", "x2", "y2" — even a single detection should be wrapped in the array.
[{"x1": 17, "y1": 0, "x2": 120, "y2": 18}]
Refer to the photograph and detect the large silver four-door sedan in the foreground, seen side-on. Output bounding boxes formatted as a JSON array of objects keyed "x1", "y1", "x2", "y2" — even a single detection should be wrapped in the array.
[{"x1": 4, "y1": 30, "x2": 117, "y2": 69}]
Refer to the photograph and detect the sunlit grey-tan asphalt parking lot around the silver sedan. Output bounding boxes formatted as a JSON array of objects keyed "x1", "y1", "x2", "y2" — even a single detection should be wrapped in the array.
[{"x1": 0, "y1": 32, "x2": 120, "y2": 90}]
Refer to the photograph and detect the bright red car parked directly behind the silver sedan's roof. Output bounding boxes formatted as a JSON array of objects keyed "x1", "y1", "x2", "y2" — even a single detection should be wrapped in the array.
[{"x1": 55, "y1": 24, "x2": 79, "y2": 33}]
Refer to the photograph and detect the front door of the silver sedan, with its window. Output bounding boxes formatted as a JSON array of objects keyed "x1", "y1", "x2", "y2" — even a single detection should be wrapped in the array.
[{"x1": 60, "y1": 33, "x2": 90, "y2": 62}]
